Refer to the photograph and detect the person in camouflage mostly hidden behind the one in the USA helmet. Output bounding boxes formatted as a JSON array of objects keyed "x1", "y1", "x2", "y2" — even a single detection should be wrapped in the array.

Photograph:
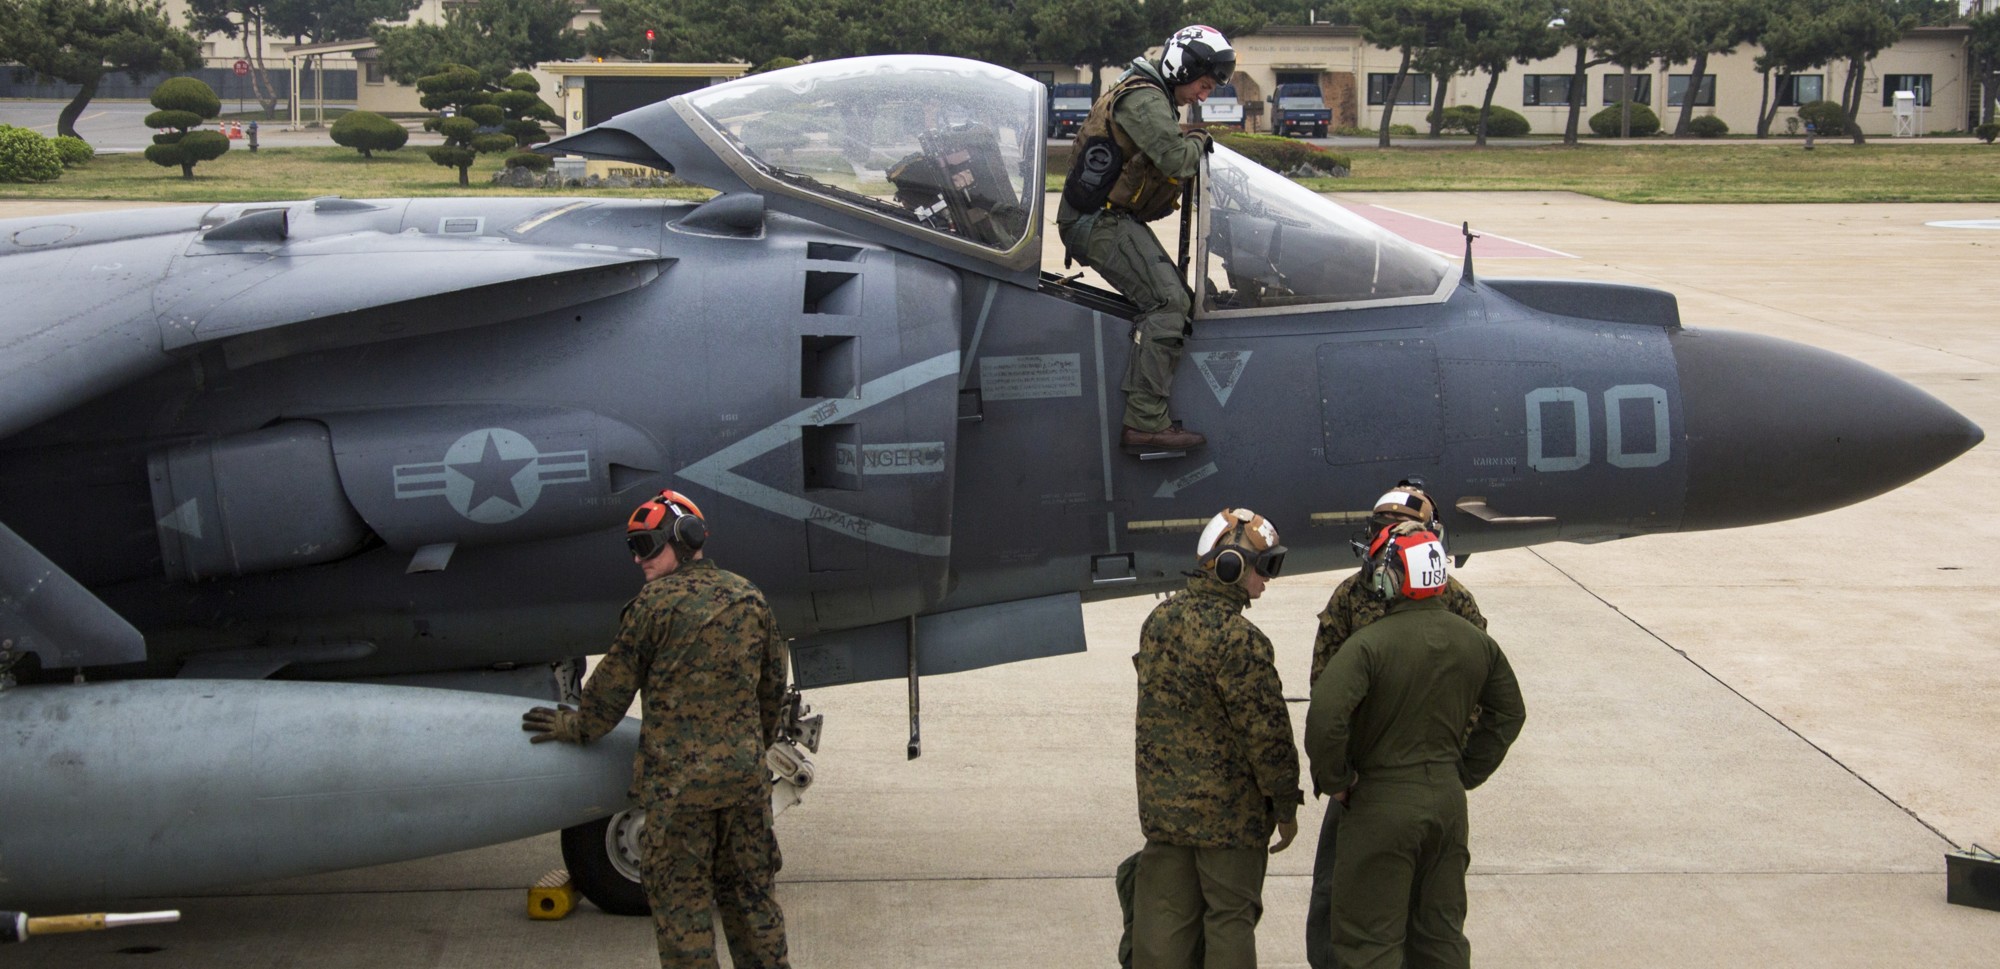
[{"x1": 1306, "y1": 480, "x2": 1486, "y2": 969}]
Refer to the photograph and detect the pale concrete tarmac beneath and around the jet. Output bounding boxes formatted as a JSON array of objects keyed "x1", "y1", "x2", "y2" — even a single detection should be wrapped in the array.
[{"x1": 0, "y1": 192, "x2": 2000, "y2": 969}]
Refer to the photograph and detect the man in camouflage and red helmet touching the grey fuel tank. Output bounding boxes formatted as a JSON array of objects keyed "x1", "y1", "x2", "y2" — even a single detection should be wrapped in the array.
[{"x1": 522, "y1": 491, "x2": 790, "y2": 969}]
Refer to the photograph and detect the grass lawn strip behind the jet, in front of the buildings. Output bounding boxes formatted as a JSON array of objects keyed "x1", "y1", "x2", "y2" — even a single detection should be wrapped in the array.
[{"x1": 0, "y1": 140, "x2": 2000, "y2": 202}]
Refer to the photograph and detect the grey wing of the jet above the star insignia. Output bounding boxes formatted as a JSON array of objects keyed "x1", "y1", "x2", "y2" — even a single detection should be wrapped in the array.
[{"x1": 0, "y1": 206, "x2": 666, "y2": 438}]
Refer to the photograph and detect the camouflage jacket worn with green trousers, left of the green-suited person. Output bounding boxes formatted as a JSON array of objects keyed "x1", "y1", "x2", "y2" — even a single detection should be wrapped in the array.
[{"x1": 1132, "y1": 575, "x2": 1304, "y2": 847}]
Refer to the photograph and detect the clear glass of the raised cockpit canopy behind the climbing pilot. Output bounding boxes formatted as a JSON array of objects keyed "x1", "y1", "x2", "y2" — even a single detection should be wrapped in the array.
[{"x1": 680, "y1": 56, "x2": 1046, "y2": 252}]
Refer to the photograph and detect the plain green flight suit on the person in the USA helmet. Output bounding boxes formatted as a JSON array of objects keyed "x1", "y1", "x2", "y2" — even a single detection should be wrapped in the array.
[{"x1": 1306, "y1": 597, "x2": 1526, "y2": 969}]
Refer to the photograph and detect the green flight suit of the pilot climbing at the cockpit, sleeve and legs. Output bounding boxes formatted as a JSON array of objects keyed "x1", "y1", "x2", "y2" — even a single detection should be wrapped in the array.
[{"x1": 1056, "y1": 58, "x2": 1204, "y2": 432}]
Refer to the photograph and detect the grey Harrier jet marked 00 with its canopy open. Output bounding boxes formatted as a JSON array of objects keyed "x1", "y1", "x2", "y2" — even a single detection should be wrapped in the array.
[{"x1": 0, "y1": 56, "x2": 1982, "y2": 911}]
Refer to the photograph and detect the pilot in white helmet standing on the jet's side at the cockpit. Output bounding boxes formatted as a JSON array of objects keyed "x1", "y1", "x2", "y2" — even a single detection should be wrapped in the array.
[{"x1": 1056, "y1": 26, "x2": 1236, "y2": 450}]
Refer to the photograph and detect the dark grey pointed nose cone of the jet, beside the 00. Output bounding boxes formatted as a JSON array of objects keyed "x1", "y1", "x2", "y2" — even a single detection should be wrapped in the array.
[{"x1": 1672, "y1": 330, "x2": 1986, "y2": 531}]
